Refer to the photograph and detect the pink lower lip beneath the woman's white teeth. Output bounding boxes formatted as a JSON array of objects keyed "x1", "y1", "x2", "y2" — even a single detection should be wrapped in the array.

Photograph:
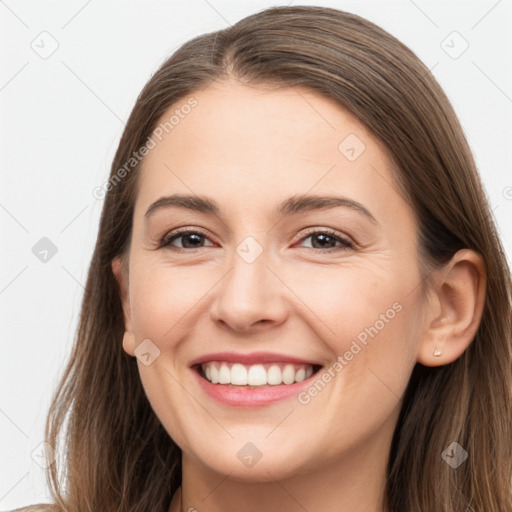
[{"x1": 192, "y1": 368, "x2": 318, "y2": 407}]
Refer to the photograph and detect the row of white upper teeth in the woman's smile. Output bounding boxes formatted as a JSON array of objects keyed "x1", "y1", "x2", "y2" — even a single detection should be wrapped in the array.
[{"x1": 201, "y1": 361, "x2": 313, "y2": 386}]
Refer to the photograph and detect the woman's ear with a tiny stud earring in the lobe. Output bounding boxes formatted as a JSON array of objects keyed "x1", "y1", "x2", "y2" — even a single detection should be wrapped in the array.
[{"x1": 417, "y1": 249, "x2": 487, "y2": 366}]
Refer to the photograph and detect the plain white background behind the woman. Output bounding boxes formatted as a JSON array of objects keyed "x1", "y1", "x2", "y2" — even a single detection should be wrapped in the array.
[{"x1": 0, "y1": 0, "x2": 512, "y2": 510}]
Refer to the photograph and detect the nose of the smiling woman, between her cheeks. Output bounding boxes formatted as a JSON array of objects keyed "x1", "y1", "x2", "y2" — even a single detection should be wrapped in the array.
[{"x1": 211, "y1": 242, "x2": 288, "y2": 333}]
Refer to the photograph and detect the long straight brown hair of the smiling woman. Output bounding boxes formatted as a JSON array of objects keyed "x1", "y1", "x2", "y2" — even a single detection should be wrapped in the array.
[{"x1": 33, "y1": 6, "x2": 512, "y2": 512}]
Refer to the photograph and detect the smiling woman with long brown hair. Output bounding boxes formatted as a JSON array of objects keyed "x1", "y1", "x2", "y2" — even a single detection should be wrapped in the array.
[{"x1": 12, "y1": 7, "x2": 512, "y2": 512}]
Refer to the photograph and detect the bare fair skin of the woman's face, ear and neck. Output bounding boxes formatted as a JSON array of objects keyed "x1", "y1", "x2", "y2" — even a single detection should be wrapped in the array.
[{"x1": 112, "y1": 81, "x2": 485, "y2": 512}]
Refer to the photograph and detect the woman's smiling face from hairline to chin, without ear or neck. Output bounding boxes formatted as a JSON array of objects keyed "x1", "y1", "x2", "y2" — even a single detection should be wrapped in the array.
[{"x1": 114, "y1": 82, "x2": 425, "y2": 481}]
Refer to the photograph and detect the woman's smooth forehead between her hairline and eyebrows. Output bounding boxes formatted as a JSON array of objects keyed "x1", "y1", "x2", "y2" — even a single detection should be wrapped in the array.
[{"x1": 137, "y1": 82, "x2": 404, "y2": 220}]
